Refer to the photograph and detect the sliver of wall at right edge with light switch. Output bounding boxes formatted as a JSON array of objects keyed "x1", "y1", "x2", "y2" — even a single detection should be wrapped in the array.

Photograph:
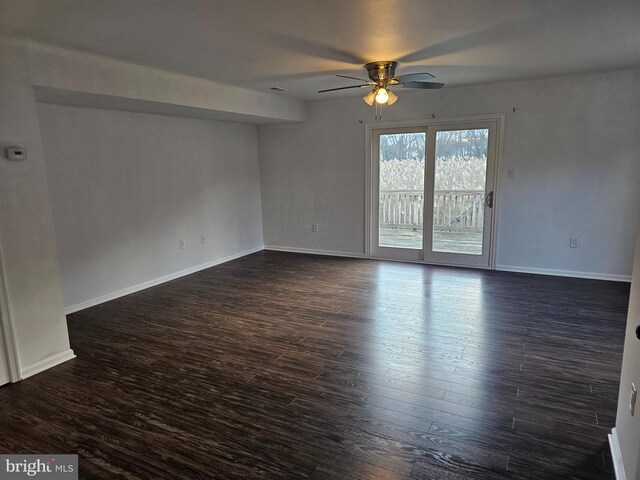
[{"x1": 615, "y1": 234, "x2": 640, "y2": 480}]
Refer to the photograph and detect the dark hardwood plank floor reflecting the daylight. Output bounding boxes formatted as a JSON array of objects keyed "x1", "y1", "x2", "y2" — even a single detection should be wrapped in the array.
[{"x1": 0, "y1": 252, "x2": 629, "y2": 480}]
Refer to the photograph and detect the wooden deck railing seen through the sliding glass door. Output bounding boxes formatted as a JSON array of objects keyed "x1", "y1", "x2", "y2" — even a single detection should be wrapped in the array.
[{"x1": 379, "y1": 190, "x2": 484, "y2": 232}]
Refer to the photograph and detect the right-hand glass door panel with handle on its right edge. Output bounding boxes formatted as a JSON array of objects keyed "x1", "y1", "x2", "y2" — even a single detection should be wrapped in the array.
[{"x1": 424, "y1": 121, "x2": 498, "y2": 267}]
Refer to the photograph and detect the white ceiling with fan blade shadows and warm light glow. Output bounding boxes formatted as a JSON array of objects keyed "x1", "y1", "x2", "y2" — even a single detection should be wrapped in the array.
[{"x1": 0, "y1": 0, "x2": 640, "y2": 100}]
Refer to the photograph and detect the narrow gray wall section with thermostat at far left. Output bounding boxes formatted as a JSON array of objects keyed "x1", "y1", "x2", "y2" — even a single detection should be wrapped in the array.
[{"x1": 0, "y1": 38, "x2": 73, "y2": 380}]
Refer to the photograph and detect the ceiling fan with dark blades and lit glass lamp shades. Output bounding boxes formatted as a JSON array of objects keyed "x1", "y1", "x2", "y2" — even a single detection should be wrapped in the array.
[{"x1": 318, "y1": 61, "x2": 444, "y2": 105}]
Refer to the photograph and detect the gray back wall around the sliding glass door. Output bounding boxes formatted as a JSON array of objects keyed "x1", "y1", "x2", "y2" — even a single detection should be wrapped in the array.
[{"x1": 260, "y1": 71, "x2": 640, "y2": 278}]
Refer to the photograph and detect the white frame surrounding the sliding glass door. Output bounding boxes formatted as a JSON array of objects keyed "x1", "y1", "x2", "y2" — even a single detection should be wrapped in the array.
[{"x1": 364, "y1": 113, "x2": 505, "y2": 270}]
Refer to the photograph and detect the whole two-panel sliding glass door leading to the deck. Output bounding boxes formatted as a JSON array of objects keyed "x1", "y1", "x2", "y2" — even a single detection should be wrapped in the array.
[{"x1": 370, "y1": 121, "x2": 497, "y2": 267}]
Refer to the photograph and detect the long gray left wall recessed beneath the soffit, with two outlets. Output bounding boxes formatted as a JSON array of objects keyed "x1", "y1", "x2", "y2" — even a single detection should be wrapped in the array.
[{"x1": 38, "y1": 104, "x2": 263, "y2": 310}]
